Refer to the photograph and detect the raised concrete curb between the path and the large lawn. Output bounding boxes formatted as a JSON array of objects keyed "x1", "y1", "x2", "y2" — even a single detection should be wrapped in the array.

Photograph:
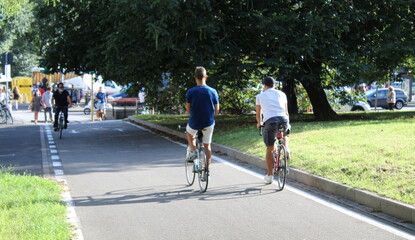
[{"x1": 128, "y1": 116, "x2": 415, "y2": 223}]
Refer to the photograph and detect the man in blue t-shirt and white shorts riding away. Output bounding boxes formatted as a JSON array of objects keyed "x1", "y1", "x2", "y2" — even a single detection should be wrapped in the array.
[{"x1": 186, "y1": 67, "x2": 219, "y2": 169}]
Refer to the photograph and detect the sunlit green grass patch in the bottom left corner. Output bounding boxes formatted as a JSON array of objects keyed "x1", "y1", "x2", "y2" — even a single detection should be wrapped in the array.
[{"x1": 0, "y1": 169, "x2": 72, "y2": 240}]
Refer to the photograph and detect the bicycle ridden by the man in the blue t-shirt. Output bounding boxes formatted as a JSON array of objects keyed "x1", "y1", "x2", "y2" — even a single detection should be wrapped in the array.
[{"x1": 185, "y1": 130, "x2": 209, "y2": 193}]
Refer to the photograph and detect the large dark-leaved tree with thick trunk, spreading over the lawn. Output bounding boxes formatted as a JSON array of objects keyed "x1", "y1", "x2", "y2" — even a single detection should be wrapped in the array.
[{"x1": 37, "y1": 0, "x2": 415, "y2": 120}]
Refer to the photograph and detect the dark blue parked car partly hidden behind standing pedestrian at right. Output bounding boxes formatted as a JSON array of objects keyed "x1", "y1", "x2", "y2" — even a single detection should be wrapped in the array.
[{"x1": 365, "y1": 88, "x2": 408, "y2": 109}]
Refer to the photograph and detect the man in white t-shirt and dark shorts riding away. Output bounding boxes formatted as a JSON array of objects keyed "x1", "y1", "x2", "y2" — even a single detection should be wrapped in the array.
[{"x1": 256, "y1": 77, "x2": 290, "y2": 183}]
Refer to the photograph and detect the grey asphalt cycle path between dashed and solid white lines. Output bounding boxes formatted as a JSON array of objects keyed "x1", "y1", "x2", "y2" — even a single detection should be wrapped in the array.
[{"x1": 48, "y1": 121, "x2": 414, "y2": 240}]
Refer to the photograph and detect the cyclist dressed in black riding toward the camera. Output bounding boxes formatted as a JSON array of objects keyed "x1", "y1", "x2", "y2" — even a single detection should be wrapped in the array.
[{"x1": 52, "y1": 83, "x2": 71, "y2": 132}]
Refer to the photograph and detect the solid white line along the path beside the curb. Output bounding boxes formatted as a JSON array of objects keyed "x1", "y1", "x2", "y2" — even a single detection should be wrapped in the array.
[{"x1": 127, "y1": 122, "x2": 415, "y2": 240}]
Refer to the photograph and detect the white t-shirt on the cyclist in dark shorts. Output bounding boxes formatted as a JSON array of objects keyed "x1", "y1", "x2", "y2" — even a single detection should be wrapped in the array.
[{"x1": 256, "y1": 88, "x2": 287, "y2": 122}]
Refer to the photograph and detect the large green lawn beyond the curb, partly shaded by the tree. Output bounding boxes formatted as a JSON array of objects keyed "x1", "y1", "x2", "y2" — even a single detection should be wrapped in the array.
[{"x1": 137, "y1": 111, "x2": 415, "y2": 205}]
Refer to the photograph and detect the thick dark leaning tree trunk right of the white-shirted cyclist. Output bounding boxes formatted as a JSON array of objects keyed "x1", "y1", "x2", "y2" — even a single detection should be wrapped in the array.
[{"x1": 300, "y1": 61, "x2": 339, "y2": 121}]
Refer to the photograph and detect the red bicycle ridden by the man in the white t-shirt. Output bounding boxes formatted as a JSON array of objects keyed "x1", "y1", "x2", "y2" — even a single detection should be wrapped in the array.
[{"x1": 259, "y1": 124, "x2": 288, "y2": 191}]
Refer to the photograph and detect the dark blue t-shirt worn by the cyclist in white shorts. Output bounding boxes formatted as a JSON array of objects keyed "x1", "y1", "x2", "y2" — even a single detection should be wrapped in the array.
[{"x1": 186, "y1": 86, "x2": 219, "y2": 130}]
